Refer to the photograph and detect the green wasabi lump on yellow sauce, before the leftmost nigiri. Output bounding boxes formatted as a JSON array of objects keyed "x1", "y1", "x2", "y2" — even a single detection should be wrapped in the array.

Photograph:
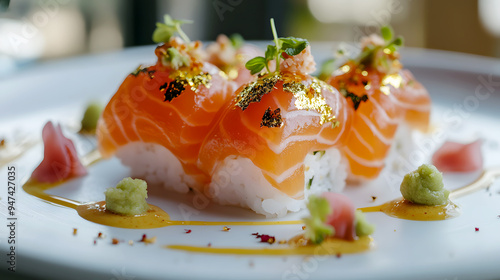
[{"x1": 104, "y1": 177, "x2": 149, "y2": 216}]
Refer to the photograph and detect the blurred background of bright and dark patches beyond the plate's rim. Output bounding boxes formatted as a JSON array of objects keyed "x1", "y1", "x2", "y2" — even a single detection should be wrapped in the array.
[{"x1": 0, "y1": 0, "x2": 500, "y2": 73}]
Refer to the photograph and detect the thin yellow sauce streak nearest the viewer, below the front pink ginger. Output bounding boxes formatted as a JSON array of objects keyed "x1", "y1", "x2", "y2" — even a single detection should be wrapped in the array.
[{"x1": 165, "y1": 236, "x2": 373, "y2": 256}]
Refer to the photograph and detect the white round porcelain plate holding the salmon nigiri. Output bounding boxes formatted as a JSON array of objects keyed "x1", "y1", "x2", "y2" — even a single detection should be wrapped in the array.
[{"x1": 0, "y1": 44, "x2": 500, "y2": 280}]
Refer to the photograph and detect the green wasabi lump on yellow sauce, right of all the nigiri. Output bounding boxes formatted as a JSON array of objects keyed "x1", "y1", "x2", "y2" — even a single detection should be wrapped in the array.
[{"x1": 400, "y1": 164, "x2": 450, "y2": 205}]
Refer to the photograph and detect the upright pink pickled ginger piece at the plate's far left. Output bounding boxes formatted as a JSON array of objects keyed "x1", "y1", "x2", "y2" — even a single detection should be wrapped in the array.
[{"x1": 31, "y1": 121, "x2": 87, "y2": 183}]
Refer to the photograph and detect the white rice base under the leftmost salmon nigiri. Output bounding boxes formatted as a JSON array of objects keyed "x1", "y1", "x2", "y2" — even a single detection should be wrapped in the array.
[{"x1": 116, "y1": 142, "x2": 195, "y2": 193}]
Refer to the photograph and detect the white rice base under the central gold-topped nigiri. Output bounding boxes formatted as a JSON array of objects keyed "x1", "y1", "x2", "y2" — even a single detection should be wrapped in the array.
[{"x1": 209, "y1": 148, "x2": 347, "y2": 218}]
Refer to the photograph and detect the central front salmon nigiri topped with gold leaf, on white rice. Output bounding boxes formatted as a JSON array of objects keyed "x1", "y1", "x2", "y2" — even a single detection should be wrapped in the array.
[{"x1": 199, "y1": 29, "x2": 352, "y2": 217}]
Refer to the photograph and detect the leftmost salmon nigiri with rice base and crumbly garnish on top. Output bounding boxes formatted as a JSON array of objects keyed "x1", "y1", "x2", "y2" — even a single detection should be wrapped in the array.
[{"x1": 97, "y1": 34, "x2": 234, "y2": 192}]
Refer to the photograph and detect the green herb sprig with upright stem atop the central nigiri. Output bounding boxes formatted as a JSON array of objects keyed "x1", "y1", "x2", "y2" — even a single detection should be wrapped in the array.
[{"x1": 245, "y1": 18, "x2": 309, "y2": 75}]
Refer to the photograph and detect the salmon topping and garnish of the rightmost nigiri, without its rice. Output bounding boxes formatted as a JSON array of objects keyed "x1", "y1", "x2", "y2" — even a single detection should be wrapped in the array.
[{"x1": 327, "y1": 28, "x2": 430, "y2": 181}]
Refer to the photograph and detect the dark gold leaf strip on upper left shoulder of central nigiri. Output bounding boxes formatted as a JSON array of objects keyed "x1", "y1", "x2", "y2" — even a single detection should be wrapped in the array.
[{"x1": 235, "y1": 74, "x2": 281, "y2": 111}]
